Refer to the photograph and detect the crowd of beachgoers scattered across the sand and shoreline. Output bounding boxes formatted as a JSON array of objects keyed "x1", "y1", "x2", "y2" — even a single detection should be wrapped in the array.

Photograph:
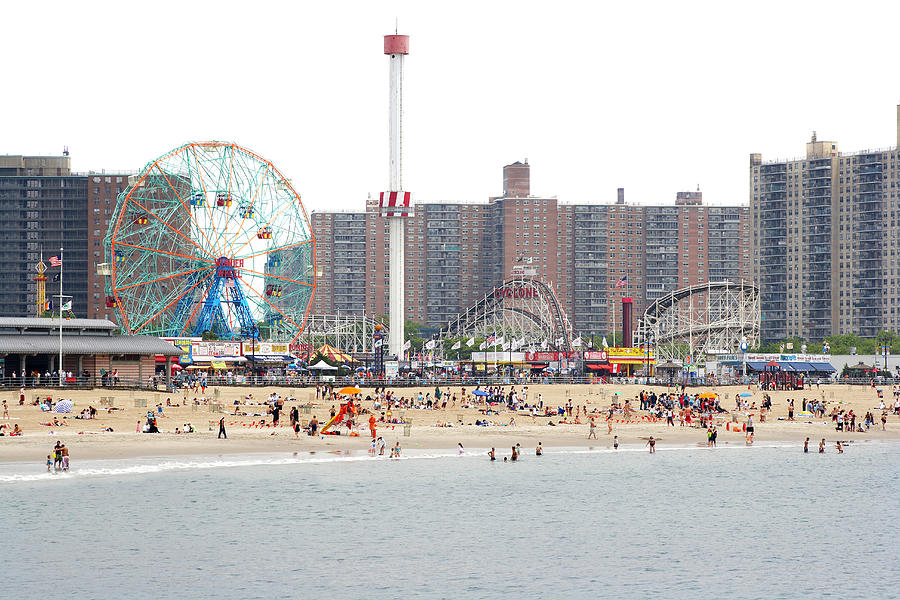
[{"x1": 0, "y1": 378, "x2": 900, "y2": 480}]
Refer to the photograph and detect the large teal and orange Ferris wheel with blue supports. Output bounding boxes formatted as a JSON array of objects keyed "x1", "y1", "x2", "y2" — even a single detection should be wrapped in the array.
[{"x1": 105, "y1": 142, "x2": 316, "y2": 341}]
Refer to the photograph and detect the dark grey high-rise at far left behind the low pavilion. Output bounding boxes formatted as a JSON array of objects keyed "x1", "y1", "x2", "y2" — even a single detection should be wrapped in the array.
[{"x1": 0, "y1": 155, "x2": 88, "y2": 317}]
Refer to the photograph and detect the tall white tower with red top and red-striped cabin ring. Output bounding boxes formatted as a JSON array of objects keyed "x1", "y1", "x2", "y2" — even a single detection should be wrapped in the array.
[{"x1": 379, "y1": 35, "x2": 412, "y2": 360}]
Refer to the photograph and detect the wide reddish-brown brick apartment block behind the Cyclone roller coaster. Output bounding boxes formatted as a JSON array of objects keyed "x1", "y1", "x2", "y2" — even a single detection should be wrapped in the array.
[{"x1": 312, "y1": 162, "x2": 750, "y2": 334}]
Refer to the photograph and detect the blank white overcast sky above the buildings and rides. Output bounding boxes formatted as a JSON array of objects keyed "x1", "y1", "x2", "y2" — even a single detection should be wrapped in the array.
[{"x1": 0, "y1": 0, "x2": 900, "y2": 211}]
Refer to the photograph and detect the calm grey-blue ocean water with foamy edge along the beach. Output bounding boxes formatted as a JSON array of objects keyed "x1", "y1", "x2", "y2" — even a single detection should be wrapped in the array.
[{"x1": 0, "y1": 442, "x2": 900, "y2": 599}]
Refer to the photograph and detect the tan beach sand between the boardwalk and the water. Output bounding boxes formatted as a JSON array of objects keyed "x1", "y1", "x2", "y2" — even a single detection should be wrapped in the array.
[{"x1": 0, "y1": 384, "x2": 900, "y2": 467}]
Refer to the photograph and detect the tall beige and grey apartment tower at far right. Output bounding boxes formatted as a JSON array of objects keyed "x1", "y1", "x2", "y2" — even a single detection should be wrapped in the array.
[{"x1": 750, "y1": 106, "x2": 900, "y2": 341}]
